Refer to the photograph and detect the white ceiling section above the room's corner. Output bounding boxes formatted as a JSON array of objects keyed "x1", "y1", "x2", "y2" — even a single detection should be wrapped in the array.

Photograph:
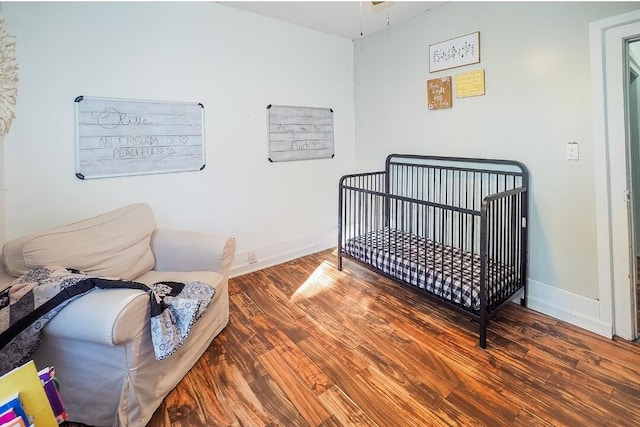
[{"x1": 219, "y1": 1, "x2": 446, "y2": 40}]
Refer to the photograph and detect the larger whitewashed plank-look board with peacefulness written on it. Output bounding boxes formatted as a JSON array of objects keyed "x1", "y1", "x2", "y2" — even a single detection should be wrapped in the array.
[{"x1": 75, "y1": 96, "x2": 205, "y2": 179}]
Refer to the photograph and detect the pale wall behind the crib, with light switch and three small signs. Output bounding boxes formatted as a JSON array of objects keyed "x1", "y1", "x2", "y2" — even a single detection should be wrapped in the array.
[{"x1": 354, "y1": 2, "x2": 638, "y2": 332}]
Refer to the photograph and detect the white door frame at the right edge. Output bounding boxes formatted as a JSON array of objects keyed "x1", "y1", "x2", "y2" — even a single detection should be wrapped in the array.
[{"x1": 589, "y1": 10, "x2": 640, "y2": 340}]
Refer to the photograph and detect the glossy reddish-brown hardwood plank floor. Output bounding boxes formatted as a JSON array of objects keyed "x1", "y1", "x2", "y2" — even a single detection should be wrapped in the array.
[{"x1": 69, "y1": 247, "x2": 640, "y2": 427}]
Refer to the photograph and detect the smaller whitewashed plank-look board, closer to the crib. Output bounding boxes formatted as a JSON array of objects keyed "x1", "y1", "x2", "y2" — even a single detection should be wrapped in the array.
[{"x1": 267, "y1": 105, "x2": 334, "y2": 162}]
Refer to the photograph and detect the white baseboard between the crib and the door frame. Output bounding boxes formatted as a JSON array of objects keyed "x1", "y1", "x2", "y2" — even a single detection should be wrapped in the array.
[{"x1": 527, "y1": 279, "x2": 613, "y2": 338}]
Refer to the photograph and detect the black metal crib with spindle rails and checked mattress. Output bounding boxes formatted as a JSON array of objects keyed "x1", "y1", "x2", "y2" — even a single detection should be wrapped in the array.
[{"x1": 338, "y1": 154, "x2": 529, "y2": 348}]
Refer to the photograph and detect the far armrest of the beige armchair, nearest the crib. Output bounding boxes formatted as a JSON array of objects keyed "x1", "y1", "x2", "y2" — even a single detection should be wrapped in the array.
[{"x1": 151, "y1": 229, "x2": 236, "y2": 277}]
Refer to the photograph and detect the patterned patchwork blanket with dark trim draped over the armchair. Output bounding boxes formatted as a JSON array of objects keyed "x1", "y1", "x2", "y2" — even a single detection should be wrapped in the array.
[{"x1": 0, "y1": 267, "x2": 215, "y2": 374}]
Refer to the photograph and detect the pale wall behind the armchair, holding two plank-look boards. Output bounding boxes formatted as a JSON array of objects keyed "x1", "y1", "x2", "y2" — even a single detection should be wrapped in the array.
[{"x1": 4, "y1": 2, "x2": 354, "y2": 274}]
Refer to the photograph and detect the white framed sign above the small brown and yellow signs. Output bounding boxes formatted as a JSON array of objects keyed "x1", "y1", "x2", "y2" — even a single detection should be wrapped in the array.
[{"x1": 429, "y1": 31, "x2": 480, "y2": 73}]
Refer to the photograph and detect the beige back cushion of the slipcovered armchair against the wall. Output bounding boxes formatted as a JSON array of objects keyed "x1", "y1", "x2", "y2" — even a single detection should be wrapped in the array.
[{"x1": 3, "y1": 203, "x2": 156, "y2": 280}]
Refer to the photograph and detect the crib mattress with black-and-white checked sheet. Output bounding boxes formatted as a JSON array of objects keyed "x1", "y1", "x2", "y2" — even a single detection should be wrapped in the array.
[{"x1": 343, "y1": 228, "x2": 515, "y2": 311}]
